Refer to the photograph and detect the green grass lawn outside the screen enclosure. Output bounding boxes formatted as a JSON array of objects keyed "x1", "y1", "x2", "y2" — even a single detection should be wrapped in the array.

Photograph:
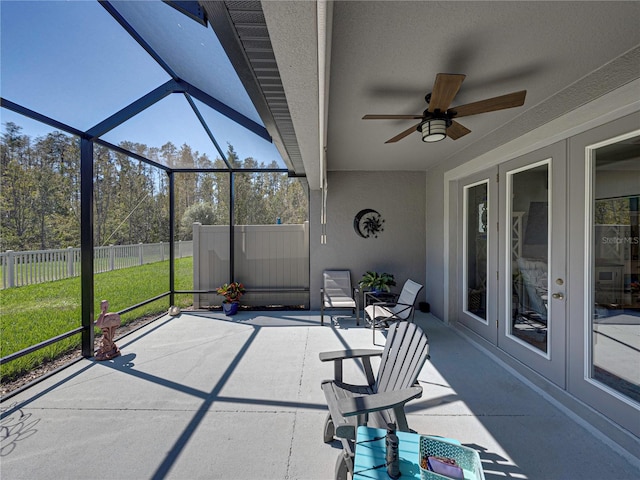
[{"x1": 0, "y1": 257, "x2": 193, "y2": 380}]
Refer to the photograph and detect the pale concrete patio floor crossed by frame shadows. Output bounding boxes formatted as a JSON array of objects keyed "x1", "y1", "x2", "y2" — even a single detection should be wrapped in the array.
[{"x1": 0, "y1": 311, "x2": 640, "y2": 480}]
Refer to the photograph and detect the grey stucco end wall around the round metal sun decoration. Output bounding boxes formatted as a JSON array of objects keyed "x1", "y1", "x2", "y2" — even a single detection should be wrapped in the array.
[{"x1": 309, "y1": 172, "x2": 424, "y2": 310}]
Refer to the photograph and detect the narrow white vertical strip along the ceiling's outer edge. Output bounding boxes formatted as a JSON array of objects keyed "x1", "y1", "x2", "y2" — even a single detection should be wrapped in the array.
[{"x1": 316, "y1": 0, "x2": 333, "y2": 245}]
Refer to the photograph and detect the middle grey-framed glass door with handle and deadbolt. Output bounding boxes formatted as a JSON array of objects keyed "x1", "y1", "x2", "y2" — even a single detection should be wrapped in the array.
[{"x1": 498, "y1": 143, "x2": 568, "y2": 388}]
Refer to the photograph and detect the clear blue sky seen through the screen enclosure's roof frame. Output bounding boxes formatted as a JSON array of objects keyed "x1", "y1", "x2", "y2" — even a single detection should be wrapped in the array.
[{"x1": 0, "y1": 0, "x2": 283, "y2": 166}]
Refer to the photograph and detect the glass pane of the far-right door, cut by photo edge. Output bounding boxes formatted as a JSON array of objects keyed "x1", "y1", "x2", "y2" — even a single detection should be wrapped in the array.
[{"x1": 589, "y1": 136, "x2": 640, "y2": 403}]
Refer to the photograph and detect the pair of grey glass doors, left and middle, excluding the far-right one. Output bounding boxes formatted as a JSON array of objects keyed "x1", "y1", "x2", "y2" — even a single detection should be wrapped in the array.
[{"x1": 458, "y1": 143, "x2": 568, "y2": 387}]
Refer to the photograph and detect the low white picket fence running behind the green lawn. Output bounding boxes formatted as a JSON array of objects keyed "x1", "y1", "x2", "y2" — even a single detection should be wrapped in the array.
[{"x1": 0, "y1": 240, "x2": 193, "y2": 288}]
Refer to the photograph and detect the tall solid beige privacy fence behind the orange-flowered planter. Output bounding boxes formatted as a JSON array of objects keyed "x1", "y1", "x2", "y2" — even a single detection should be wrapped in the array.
[{"x1": 193, "y1": 222, "x2": 309, "y2": 308}]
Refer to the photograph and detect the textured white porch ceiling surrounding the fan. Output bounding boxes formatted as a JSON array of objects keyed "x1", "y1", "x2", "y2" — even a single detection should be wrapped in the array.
[{"x1": 262, "y1": 1, "x2": 640, "y2": 188}]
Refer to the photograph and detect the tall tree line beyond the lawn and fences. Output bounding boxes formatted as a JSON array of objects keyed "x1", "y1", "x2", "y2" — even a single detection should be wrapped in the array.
[{"x1": 0, "y1": 122, "x2": 308, "y2": 251}]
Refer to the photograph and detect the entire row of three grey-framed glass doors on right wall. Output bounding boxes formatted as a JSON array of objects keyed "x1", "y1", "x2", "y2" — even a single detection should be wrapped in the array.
[{"x1": 458, "y1": 112, "x2": 640, "y2": 436}]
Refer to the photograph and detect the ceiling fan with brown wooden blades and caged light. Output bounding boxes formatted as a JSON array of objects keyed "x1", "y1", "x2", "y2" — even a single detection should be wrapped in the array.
[{"x1": 362, "y1": 73, "x2": 527, "y2": 143}]
